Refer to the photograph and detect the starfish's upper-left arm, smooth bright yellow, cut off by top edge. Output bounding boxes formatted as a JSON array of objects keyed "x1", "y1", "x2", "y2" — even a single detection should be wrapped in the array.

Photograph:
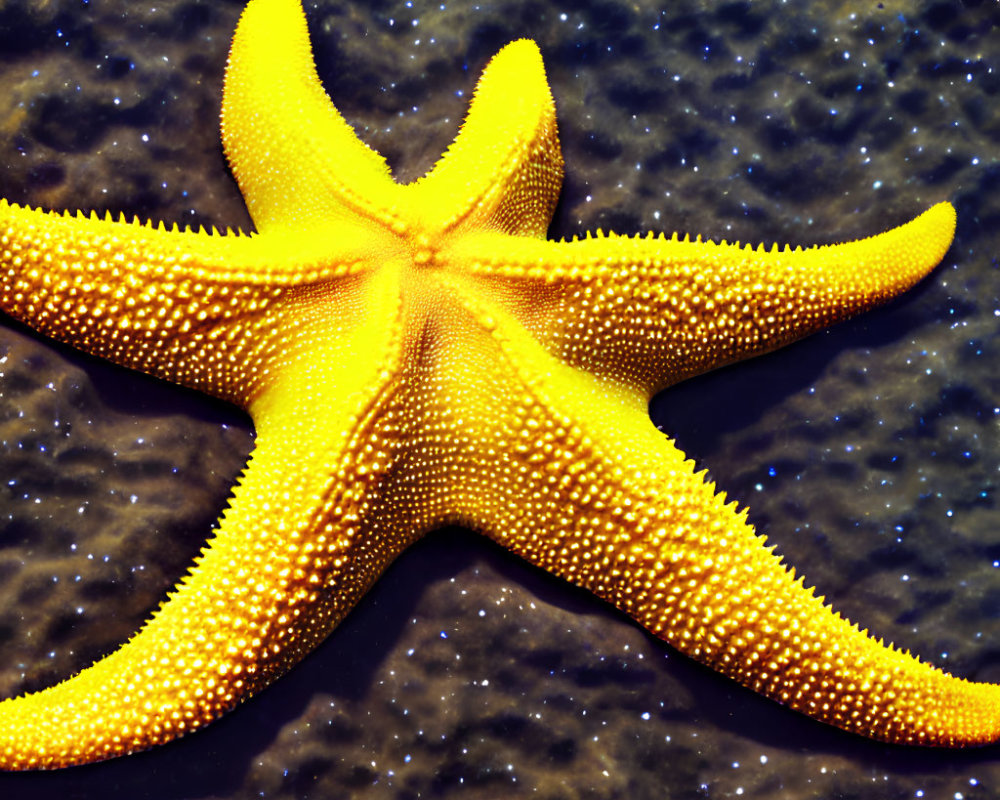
[{"x1": 222, "y1": 0, "x2": 399, "y2": 231}]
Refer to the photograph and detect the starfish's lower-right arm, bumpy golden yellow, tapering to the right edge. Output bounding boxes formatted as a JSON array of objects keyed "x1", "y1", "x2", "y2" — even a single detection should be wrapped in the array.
[{"x1": 462, "y1": 348, "x2": 1000, "y2": 746}]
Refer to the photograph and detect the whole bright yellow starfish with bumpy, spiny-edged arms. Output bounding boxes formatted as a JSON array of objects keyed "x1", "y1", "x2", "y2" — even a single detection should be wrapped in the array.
[{"x1": 0, "y1": 0, "x2": 976, "y2": 769}]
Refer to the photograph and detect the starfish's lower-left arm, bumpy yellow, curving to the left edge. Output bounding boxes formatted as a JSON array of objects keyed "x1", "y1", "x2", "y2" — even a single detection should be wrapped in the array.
[{"x1": 0, "y1": 274, "x2": 412, "y2": 770}]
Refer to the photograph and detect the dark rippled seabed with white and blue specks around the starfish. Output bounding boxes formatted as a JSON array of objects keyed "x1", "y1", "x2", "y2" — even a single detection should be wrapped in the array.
[{"x1": 0, "y1": 0, "x2": 1000, "y2": 798}]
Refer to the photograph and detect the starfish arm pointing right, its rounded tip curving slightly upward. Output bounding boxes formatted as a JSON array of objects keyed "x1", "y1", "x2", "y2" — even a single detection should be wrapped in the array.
[{"x1": 451, "y1": 203, "x2": 955, "y2": 398}]
